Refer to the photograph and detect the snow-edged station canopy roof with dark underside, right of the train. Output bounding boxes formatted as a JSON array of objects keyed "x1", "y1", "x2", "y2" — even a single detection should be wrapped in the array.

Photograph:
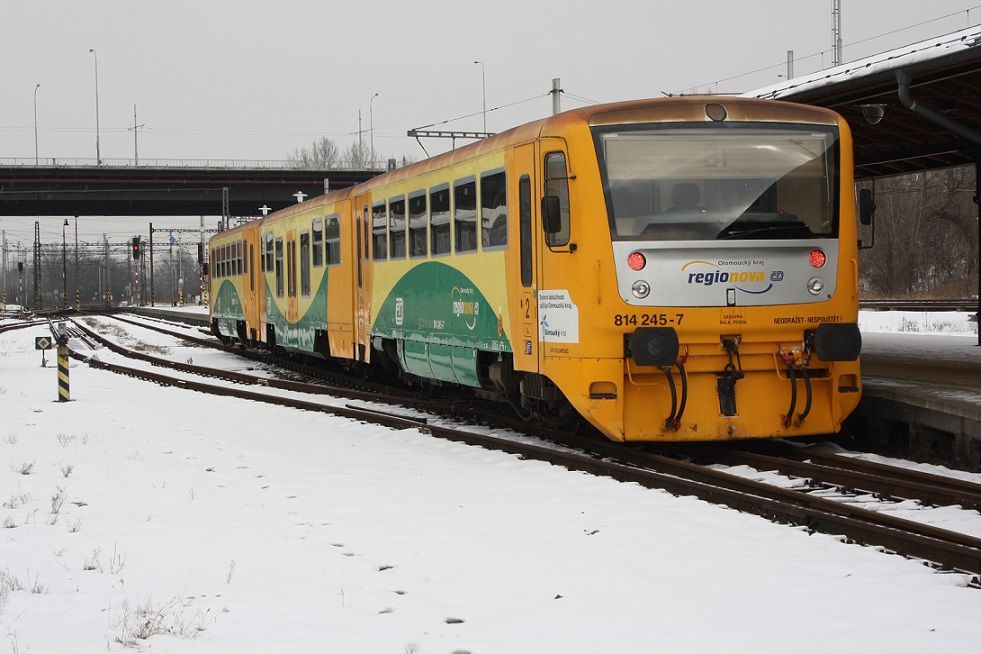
[{"x1": 743, "y1": 26, "x2": 981, "y2": 179}]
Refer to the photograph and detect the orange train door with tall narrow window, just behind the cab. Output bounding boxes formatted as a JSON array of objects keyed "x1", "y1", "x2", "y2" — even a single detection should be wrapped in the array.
[{"x1": 508, "y1": 143, "x2": 539, "y2": 373}]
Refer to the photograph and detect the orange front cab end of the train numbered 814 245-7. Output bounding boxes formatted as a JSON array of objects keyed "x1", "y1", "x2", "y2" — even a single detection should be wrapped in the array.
[{"x1": 509, "y1": 98, "x2": 860, "y2": 441}]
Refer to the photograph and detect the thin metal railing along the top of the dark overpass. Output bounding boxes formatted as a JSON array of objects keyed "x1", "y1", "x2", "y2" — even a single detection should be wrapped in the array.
[{"x1": 0, "y1": 157, "x2": 390, "y2": 170}]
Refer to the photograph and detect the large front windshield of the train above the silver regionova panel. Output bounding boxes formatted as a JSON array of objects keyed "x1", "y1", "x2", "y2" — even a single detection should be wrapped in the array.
[{"x1": 596, "y1": 123, "x2": 838, "y2": 241}]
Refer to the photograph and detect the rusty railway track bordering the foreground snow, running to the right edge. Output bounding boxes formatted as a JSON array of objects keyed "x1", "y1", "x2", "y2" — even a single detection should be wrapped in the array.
[{"x1": 55, "y1": 316, "x2": 981, "y2": 585}]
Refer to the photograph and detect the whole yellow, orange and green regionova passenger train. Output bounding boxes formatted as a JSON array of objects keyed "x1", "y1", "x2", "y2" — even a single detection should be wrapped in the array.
[{"x1": 209, "y1": 96, "x2": 861, "y2": 441}]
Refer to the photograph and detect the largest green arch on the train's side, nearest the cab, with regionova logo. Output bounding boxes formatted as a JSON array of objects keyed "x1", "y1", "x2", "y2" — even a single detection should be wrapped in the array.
[{"x1": 371, "y1": 261, "x2": 511, "y2": 352}]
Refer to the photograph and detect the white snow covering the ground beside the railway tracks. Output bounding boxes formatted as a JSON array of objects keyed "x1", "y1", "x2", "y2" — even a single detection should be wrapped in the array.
[{"x1": 0, "y1": 312, "x2": 981, "y2": 654}]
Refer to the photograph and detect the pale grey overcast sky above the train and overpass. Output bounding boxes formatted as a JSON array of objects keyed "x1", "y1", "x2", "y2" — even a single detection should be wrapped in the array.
[{"x1": 0, "y1": 0, "x2": 981, "y2": 249}]
